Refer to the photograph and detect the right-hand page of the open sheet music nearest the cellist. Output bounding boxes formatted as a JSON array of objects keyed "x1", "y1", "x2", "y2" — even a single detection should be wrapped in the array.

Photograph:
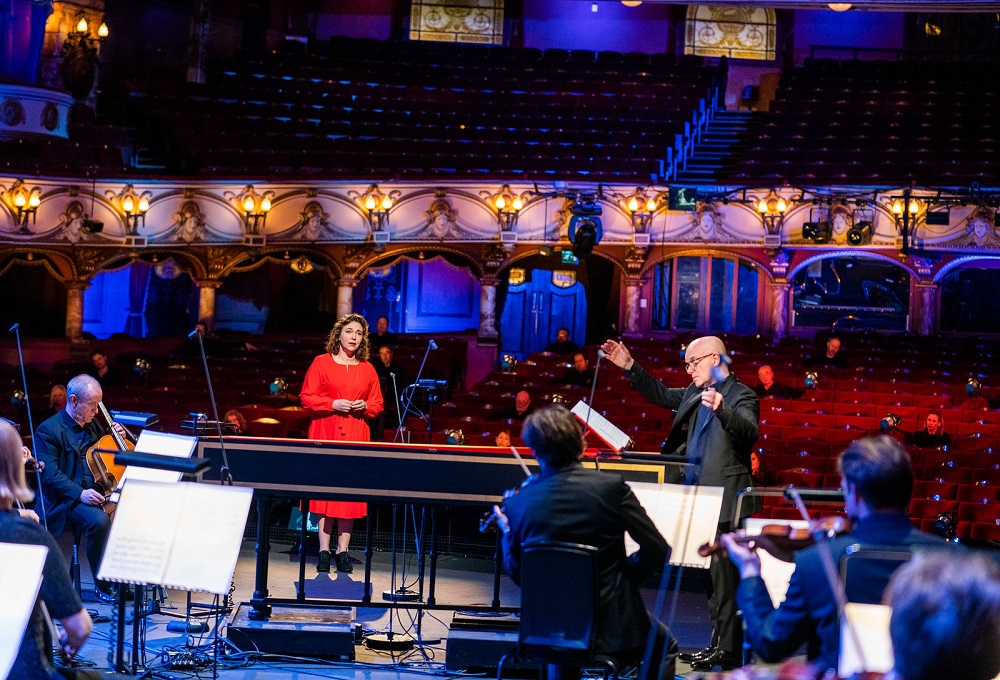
[{"x1": 163, "y1": 483, "x2": 253, "y2": 595}]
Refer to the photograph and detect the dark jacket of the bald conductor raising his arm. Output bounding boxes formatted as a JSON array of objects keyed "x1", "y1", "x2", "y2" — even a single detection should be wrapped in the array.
[{"x1": 625, "y1": 363, "x2": 760, "y2": 524}]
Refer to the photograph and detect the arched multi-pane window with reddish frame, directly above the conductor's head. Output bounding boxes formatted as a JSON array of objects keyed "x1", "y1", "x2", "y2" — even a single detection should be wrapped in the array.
[{"x1": 653, "y1": 257, "x2": 760, "y2": 333}]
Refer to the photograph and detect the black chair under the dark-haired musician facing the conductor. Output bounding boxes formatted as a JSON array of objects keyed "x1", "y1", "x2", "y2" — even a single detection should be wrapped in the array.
[{"x1": 497, "y1": 541, "x2": 618, "y2": 680}]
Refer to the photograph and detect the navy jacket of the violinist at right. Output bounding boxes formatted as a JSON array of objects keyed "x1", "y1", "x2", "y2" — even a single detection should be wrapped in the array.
[{"x1": 736, "y1": 513, "x2": 944, "y2": 669}]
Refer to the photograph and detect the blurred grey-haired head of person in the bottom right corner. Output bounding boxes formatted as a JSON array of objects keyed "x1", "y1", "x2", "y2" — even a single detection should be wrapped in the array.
[{"x1": 885, "y1": 551, "x2": 1000, "y2": 680}]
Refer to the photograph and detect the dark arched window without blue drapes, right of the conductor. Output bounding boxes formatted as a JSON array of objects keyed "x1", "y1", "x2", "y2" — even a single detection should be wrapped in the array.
[{"x1": 792, "y1": 256, "x2": 910, "y2": 331}]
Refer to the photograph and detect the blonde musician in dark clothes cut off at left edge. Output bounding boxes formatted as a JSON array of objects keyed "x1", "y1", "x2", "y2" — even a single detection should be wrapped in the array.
[{"x1": 0, "y1": 420, "x2": 101, "y2": 680}]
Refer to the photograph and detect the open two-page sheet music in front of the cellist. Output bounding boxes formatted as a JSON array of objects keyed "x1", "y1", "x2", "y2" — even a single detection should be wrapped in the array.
[{"x1": 98, "y1": 479, "x2": 253, "y2": 595}]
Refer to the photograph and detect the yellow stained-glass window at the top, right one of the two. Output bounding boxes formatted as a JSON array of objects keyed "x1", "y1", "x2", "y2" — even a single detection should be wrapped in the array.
[{"x1": 684, "y1": 5, "x2": 776, "y2": 61}]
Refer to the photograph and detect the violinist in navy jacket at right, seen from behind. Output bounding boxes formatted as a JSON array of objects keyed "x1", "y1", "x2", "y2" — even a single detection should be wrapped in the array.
[{"x1": 722, "y1": 436, "x2": 943, "y2": 669}]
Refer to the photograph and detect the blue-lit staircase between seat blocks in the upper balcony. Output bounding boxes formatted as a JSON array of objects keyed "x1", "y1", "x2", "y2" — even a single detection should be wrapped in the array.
[{"x1": 675, "y1": 111, "x2": 764, "y2": 185}]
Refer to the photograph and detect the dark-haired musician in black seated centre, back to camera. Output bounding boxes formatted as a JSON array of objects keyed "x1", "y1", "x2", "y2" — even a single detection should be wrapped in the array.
[{"x1": 494, "y1": 404, "x2": 677, "y2": 678}]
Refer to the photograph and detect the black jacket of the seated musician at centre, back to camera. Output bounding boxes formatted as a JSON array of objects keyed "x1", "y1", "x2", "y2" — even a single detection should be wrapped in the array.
[{"x1": 503, "y1": 463, "x2": 669, "y2": 653}]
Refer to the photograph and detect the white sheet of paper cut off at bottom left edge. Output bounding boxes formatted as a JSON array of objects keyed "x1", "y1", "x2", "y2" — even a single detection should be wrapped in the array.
[{"x1": 0, "y1": 543, "x2": 49, "y2": 678}]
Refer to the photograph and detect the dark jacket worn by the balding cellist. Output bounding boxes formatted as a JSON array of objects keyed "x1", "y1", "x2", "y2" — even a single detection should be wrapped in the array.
[{"x1": 32, "y1": 409, "x2": 102, "y2": 536}]
